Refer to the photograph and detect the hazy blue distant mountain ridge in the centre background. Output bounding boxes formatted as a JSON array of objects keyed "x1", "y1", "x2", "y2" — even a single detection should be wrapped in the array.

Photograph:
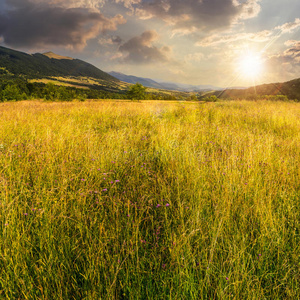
[{"x1": 109, "y1": 71, "x2": 222, "y2": 92}]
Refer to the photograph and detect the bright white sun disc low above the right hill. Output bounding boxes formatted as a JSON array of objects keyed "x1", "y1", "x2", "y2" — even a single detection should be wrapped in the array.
[{"x1": 239, "y1": 53, "x2": 263, "y2": 79}]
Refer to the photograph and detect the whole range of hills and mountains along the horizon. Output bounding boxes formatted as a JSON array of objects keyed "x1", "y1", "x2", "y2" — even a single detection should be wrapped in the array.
[{"x1": 0, "y1": 46, "x2": 300, "y2": 100}]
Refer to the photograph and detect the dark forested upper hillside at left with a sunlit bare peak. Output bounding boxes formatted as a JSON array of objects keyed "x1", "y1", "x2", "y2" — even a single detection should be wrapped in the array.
[{"x1": 0, "y1": 47, "x2": 119, "y2": 82}]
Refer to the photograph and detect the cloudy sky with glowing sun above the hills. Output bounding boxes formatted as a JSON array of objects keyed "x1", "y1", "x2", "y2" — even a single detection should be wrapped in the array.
[{"x1": 0, "y1": 0, "x2": 300, "y2": 87}]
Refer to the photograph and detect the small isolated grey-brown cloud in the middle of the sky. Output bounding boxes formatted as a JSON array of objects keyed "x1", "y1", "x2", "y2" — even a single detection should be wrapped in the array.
[{"x1": 118, "y1": 30, "x2": 171, "y2": 64}]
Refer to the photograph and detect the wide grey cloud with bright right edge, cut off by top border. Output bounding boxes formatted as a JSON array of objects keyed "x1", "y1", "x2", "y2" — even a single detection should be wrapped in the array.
[{"x1": 117, "y1": 0, "x2": 260, "y2": 34}]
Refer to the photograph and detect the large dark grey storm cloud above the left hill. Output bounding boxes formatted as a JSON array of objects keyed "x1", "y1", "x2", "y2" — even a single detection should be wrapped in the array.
[{"x1": 0, "y1": 0, "x2": 125, "y2": 48}]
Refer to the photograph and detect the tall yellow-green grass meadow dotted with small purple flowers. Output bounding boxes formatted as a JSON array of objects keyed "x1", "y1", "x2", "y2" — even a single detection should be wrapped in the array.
[{"x1": 0, "y1": 101, "x2": 300, "y2": 299}]
